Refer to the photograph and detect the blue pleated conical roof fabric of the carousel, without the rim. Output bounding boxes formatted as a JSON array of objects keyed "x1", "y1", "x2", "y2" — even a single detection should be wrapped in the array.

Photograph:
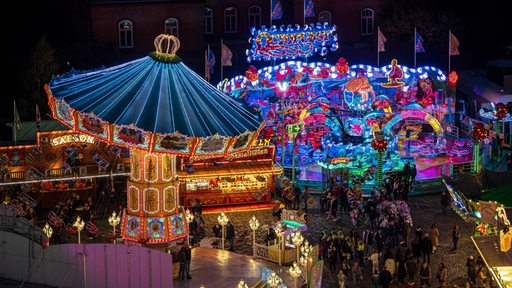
[{"x1": 49, "y1": 56, "x2": 262, "y2": 137}]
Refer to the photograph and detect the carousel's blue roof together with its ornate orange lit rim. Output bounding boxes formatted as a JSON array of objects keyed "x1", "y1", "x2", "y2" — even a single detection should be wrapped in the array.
[{"x1": 45, "y1": 36, "x2": 263, "y2": 156}]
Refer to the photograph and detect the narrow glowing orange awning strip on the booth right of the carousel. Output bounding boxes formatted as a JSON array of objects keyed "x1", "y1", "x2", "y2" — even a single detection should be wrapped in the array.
[{"x1": 177, "y1": 164, "x2": 283, "y2": 180}]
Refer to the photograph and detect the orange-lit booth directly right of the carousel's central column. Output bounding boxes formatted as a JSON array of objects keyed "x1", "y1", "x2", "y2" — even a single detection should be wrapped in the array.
[{"x1": 177, "y1": 146, "x2": 282, "y2": 207}]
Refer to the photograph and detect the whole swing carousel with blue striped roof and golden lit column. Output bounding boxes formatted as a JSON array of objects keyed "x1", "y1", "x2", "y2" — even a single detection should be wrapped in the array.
[{"x1": 45, "y1": 35, "x2": 264, "y2": 244}]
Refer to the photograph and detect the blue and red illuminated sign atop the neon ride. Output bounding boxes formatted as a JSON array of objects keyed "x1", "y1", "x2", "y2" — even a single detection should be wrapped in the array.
[{"x1": 246, "y1": 23, "x2": 338, "y2": 62}]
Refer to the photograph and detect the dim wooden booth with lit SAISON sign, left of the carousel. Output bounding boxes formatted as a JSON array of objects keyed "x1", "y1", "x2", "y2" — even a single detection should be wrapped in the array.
[{"x1": 0, "y1": 130, "x2": 130, "y2": 208}]
